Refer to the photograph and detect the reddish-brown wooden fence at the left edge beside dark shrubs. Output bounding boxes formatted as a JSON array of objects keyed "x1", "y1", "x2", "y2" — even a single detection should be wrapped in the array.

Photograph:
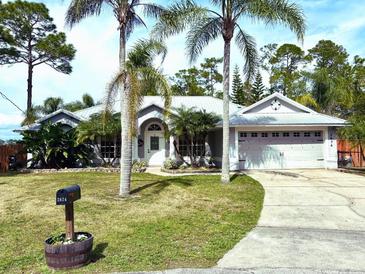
[{"x1": 0, "y1": 144, "x2": 27, "y2": 173}]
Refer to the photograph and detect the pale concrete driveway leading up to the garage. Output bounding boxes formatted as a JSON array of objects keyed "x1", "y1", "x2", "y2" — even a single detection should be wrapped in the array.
[{"x1": 218, "y1": 170, "x2": 365, "y2": 273}]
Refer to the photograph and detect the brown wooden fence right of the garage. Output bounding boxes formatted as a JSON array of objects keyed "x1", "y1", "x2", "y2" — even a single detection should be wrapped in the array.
[{"x1": 337, "y1": 140, "x2": 365, "y2": 167}]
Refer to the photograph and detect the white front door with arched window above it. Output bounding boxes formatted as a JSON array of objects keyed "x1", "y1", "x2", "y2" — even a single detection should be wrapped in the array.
[{"x1": 145, "y1": 124, "x2": 165, "y2": 166}]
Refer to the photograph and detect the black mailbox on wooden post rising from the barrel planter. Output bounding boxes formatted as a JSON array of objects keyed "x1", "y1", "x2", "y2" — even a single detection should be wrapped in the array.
[{"x1": 56, "y1": 185, "x2": 81, "y2": 241}]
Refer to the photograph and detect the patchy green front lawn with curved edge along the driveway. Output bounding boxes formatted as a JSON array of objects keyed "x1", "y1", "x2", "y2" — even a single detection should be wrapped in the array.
[{"x1": 0, "y1": 173, "x2": 264, "y2": 273}]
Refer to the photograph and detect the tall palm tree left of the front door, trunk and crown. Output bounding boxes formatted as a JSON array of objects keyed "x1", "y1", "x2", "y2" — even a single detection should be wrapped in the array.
[{"x1": 66, "y1": 0, "x2": 163, "y2": 197}]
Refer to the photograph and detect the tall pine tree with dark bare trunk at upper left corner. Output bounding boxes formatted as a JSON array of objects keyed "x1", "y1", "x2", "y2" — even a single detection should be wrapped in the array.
[{"x1": 0, "y1": 0, "x2": 76, "y2": 113}]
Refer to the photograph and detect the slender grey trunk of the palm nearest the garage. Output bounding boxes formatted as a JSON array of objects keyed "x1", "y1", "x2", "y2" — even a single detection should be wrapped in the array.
[{"x1": 221, "y1": 40, "x2": 231, "y2": 183}]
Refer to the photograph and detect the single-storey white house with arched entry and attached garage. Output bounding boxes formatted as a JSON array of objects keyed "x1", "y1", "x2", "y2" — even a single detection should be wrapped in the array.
[{"x1": 22, "y1": 93, "x2": 346, "y2": 170}]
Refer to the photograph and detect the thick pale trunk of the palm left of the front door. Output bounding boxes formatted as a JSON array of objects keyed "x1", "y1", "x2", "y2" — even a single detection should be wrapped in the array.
[{"x1": 119, "y1": 25, "x2": 132, "y2": 197}]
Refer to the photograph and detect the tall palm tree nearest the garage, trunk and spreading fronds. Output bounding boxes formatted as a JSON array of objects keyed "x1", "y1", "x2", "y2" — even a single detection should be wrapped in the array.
[{"x1": 154, "y1": 0, "x2": 305, "y2": 183}]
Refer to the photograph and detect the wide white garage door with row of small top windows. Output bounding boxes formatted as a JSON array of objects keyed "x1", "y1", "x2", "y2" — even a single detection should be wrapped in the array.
[{"x1": 238, "y1": 131, "x2": 324, "y2": 169}]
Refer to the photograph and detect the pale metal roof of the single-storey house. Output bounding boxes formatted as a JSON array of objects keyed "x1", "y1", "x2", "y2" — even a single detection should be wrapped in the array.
[{"x1": 15, "y1": 94, "x2": 346, "y2": 133}]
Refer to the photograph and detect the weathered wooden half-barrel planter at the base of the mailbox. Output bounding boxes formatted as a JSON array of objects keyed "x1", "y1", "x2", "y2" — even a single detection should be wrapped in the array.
[{"x1": 44, "y1": 232, "x2": 94, "y2": 269}]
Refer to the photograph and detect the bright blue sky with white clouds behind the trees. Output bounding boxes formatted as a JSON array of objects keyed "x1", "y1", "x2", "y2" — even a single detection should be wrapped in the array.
[{"x1": 0, "y1": 0, "x2": 365, "y2": 139}]
